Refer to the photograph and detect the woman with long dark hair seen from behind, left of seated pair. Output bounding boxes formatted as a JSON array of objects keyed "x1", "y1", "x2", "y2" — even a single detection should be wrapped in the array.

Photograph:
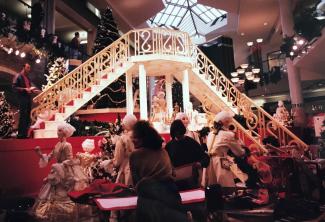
[{"x1": 130, "y1": 121, "x2": 188, "y2": 222}]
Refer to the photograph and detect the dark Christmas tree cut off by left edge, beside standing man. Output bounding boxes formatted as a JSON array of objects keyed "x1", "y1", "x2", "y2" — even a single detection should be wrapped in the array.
[{"x1": 0, "y1": 92, "x2": 14, "y2": 138}]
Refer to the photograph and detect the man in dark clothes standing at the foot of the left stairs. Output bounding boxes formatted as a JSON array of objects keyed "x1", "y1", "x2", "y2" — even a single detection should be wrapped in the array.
[{"x1": 12, "y1": 63, "x2": 37, "y2": 139}]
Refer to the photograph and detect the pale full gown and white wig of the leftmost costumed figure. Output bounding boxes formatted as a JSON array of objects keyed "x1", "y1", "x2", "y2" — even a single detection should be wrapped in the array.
[{"x1": 32, "y1": 123, "x2": 88, "y2": 221}]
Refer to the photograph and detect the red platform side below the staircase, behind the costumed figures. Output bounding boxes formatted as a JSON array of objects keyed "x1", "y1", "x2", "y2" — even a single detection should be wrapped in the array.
[{"x1": 0, "y1": 135, "x2": 169, "y2": 196}]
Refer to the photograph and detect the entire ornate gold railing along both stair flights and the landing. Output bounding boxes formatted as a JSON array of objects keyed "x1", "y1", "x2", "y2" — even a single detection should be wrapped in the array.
[{"x1": 31, "y1": 28, "x2": 307, "y2": 149}]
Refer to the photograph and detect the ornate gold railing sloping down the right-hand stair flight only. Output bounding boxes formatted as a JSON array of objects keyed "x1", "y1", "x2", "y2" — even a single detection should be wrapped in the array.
[{"x1": 191, "y1": 45, "x2": 308, "y2": 150}]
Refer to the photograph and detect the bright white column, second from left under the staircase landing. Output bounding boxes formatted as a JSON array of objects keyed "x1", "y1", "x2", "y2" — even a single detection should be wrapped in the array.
[{"x1": 139, "y1": 64, "x2": 148, "y2": 120}]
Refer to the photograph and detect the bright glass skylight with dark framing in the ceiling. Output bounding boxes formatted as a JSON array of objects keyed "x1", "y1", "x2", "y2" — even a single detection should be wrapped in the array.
[{"x1": 147, "y1": 0, "x2": 227, "y2": 44}]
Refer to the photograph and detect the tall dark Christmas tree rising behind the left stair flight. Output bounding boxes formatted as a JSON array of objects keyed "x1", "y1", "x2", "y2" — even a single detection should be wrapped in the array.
[{"x1": 91, "y1": 8, "x2": 126, "y2": 108}]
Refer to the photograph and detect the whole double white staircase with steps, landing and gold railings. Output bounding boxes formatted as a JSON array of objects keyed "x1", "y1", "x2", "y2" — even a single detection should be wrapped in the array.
[{"x1": 32, "y1": 28, "x2": 307, "y2": 151}]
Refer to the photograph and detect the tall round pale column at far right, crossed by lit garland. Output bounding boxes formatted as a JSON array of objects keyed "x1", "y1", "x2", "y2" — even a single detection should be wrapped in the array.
[{"x1": 279, "y1": 0, "x2": 305, "y2": 126}]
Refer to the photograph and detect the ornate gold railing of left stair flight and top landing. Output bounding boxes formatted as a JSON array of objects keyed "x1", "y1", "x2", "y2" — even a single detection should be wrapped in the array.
[{"x1": 31, "y1": 29, "x2": 191, "y2": 121}]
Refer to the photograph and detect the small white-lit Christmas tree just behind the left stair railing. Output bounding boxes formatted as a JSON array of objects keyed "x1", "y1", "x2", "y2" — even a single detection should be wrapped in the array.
[{"x1": 42, "y1": 57, "x2": 67, "y2": 90}]
